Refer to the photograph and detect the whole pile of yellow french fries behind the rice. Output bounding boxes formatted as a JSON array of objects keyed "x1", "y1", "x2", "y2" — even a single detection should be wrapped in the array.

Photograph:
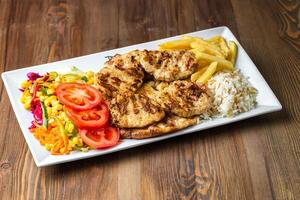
[{"x1": 159, "y1": 36, "x2": 237, "y2": 83}]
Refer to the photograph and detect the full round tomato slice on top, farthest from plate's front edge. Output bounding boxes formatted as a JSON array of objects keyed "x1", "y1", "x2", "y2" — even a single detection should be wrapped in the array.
[{"x1": 56, "y1": 83, "x2": 103, "y2": 110}]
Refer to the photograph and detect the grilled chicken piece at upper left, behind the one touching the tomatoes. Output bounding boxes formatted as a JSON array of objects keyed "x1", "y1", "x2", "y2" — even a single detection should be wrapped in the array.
[{"x1": 95, "y1": 53, "x2": 144, "y2": 101}]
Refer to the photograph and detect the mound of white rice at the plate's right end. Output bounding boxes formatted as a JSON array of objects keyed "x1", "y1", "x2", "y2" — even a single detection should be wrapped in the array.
[{"x1": 202, "y1": 70, "x2": 257, "y2": 118}]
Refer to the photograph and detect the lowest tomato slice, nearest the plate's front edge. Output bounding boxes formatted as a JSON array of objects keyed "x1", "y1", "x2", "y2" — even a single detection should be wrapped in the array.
[{"x1": 79, "y1": 126, "x2": 120, "y2": 149}]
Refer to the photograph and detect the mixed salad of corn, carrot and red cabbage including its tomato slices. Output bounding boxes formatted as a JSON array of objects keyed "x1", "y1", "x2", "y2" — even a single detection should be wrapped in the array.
[{"x1": 20, "y1": 67, "x2": 120, "y2": 155}]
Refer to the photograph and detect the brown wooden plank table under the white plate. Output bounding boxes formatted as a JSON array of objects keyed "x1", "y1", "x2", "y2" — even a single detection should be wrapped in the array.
[{"x1": 0, "y1": 0, "x2": 300, "y2": 200}]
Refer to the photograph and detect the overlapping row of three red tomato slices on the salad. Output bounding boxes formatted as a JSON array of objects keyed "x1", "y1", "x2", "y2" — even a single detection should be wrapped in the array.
[{"x1": 56, "y1": 83, "x2": 120, "y2": 149}]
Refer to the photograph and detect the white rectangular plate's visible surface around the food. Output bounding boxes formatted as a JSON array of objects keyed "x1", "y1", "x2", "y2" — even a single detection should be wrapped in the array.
[{"x1": 2, "y1": 27, "x2": 282, "y2": 167}]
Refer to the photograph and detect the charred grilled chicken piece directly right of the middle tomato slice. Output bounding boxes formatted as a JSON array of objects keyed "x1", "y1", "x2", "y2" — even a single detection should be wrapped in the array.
[{"x1": 109, "y1": 93, "x2": 165, "y2": 128}]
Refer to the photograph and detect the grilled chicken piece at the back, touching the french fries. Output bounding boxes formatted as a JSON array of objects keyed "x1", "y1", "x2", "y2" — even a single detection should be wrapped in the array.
[{"x1": 135, "y1": 50, "x2": 198, "y2": 82}]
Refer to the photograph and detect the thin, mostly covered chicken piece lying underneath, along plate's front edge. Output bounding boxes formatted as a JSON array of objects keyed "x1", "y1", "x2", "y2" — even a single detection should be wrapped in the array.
[{"x1": 120, "y1": 115, "x2": 198, "y2": 139}]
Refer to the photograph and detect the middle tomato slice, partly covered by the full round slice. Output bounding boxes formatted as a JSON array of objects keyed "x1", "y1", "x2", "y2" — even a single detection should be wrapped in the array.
[{"x1": 65, "y1": 103, "x2": 109, "y2": 128}]
